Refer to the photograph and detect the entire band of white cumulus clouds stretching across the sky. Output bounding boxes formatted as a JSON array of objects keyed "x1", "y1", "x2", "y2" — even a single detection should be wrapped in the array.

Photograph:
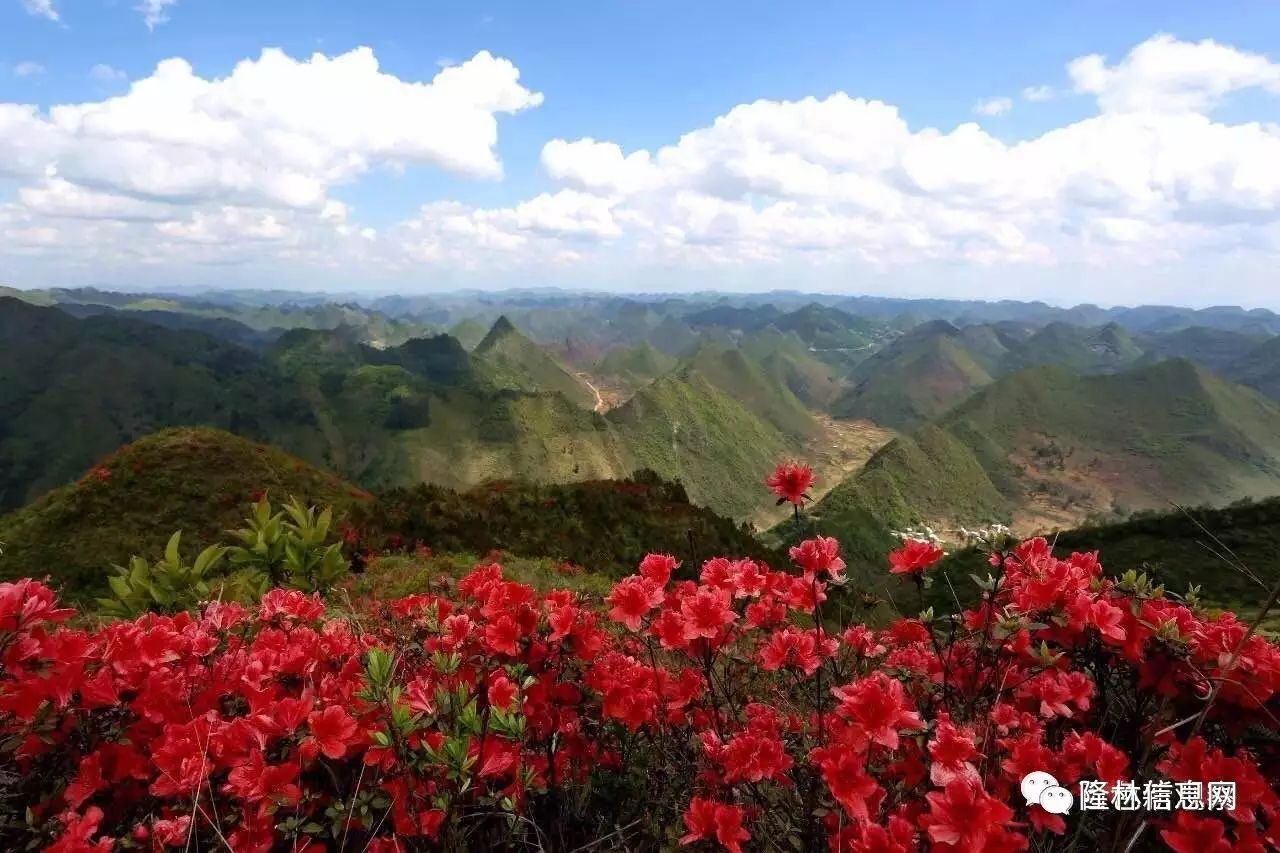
[{"x1": 0, "y1": 36, "x2": 1280, "y2": 306}]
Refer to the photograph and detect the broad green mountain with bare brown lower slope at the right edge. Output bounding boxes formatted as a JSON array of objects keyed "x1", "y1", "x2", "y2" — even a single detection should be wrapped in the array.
[{"x1": 814, "y1": 360, "x2": 1280, "y2": 555}]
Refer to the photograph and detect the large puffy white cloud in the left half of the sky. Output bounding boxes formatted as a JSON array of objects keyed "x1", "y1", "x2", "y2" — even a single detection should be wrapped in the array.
[{"x1": 0, "y1": 49, "x2": 541, "y2": 209}]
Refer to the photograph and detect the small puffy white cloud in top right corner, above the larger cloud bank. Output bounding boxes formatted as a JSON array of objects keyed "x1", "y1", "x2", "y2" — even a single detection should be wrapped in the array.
[{"x1": 1068, "y1": 35, "x2": 1280, "y2": 113}]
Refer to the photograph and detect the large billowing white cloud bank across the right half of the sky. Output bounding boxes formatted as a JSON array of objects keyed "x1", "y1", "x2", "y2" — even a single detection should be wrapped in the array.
[{"x1": 509, "y1": 37, "x2": 1280, "y2": 275}]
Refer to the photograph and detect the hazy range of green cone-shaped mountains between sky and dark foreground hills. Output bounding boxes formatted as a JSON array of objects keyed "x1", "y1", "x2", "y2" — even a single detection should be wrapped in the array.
[{"x1": 0, "y1": 281, "x2": 1280, "y2": 568}]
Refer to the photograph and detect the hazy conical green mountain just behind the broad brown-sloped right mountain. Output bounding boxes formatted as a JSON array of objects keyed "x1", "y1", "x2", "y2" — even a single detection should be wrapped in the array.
[{"x1": 831, "y1": 320, "x2": 1002, "y2": 429}]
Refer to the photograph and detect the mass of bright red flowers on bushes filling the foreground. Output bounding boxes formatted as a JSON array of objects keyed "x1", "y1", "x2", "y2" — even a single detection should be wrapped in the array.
[{"x1": 0, "y1": 514, "x2": 1280, "y2": 853}]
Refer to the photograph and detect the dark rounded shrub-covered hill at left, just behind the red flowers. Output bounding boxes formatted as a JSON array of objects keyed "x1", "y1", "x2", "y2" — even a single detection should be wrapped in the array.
[{"x1": 0, "y1": 428, "x2": 369, "y2": 596}]
